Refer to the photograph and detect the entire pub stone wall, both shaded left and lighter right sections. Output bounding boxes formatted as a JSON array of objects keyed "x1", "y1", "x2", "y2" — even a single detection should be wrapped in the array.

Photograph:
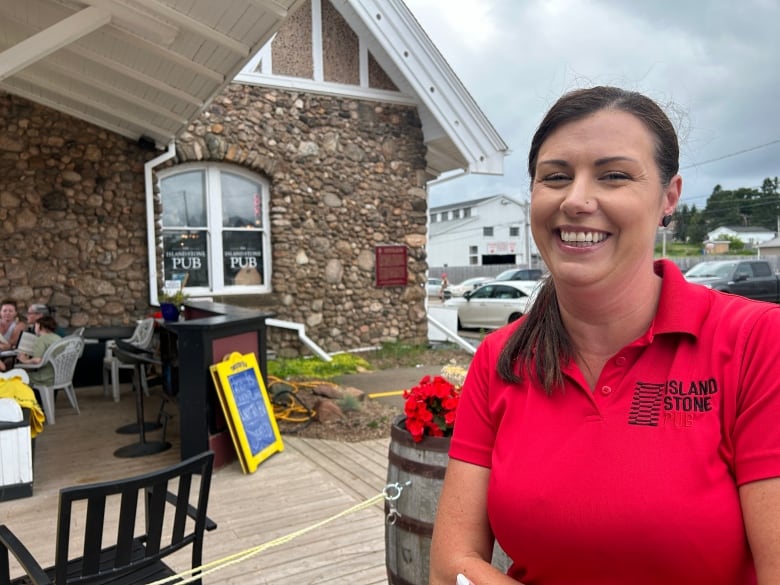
[{"x1": 0, "y1": 85, "x2": 427, "y2": 355}]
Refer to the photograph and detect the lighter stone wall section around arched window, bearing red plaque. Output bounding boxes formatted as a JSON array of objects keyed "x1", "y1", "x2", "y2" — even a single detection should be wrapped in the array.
[{"x1": 171, "y1": 84, "x2": 427, "y2": 355}]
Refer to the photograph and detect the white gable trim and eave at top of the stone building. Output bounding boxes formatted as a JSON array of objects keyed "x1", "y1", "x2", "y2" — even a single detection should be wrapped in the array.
[{"x1": 235, "y1": 0, "x2": 509, "y2": 177}]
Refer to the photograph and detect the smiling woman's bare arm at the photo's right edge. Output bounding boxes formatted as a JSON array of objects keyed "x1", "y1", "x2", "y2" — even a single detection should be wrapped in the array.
[{"x1": 739, "y1": 477, "x2": 780, "y2": 585}]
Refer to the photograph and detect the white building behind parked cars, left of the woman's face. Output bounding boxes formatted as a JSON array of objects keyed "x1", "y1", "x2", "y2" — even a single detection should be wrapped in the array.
[{"x1": 428, "y1": 195, "x2": 539, "y2": 266}]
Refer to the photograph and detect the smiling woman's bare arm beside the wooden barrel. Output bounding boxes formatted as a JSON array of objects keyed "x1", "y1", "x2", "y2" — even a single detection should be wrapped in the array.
[{"x1": 429, "y1": 459, "x2": 517, "y2": 585}]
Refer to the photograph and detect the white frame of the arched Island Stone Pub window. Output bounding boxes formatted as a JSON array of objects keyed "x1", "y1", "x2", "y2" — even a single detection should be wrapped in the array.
[{"x1": 158, "y1": 162, "x2": 271, "y2": 296}]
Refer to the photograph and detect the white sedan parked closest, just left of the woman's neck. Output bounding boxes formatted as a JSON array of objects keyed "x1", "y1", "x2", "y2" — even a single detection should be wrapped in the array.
[{"x1": 444, "y1": 280, "x2": 539, "y2": 329}]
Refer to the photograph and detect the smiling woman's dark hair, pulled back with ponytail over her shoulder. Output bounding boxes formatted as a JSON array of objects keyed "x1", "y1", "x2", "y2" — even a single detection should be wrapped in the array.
[{"x1": 497, "y1": 86, "x2": 680, "y2": 394}]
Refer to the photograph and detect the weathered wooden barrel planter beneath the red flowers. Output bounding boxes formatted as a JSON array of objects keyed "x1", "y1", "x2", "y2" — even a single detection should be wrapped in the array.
[{"x1": 385, "y1": 416, "x2": 450, "y2": 585}]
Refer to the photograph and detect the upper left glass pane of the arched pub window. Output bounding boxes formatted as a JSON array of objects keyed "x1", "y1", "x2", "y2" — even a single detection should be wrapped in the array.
[{"x1": 160, "y1": 171, "x2": 206, "y2": 227}]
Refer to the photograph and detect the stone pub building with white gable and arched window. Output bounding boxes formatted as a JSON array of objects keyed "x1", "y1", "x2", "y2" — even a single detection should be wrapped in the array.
[{"x1": 0, "y1": 0, "x2": 507, "y2": 355}]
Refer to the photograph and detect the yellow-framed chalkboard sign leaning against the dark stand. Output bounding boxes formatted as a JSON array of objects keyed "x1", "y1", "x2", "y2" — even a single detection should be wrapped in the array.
[{"x1": 210, "y1": 353, "x2": 284, "y2": 473}]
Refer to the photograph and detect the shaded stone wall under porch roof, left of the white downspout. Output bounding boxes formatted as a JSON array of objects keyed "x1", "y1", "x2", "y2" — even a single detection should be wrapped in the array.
[{"x1": 0, "y1": 92, "x2": 154, "y2": 327}]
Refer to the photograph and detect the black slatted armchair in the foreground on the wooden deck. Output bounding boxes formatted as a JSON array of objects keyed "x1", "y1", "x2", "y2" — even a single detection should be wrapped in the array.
[{"x1": 0, "y1": 451, "x2": 217, "y2": 585}]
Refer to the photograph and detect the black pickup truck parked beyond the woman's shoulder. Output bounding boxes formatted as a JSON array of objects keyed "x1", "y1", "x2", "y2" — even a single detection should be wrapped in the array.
[{"x1": 685, "y1": 260, "x2": 780, "y2": 303}]
